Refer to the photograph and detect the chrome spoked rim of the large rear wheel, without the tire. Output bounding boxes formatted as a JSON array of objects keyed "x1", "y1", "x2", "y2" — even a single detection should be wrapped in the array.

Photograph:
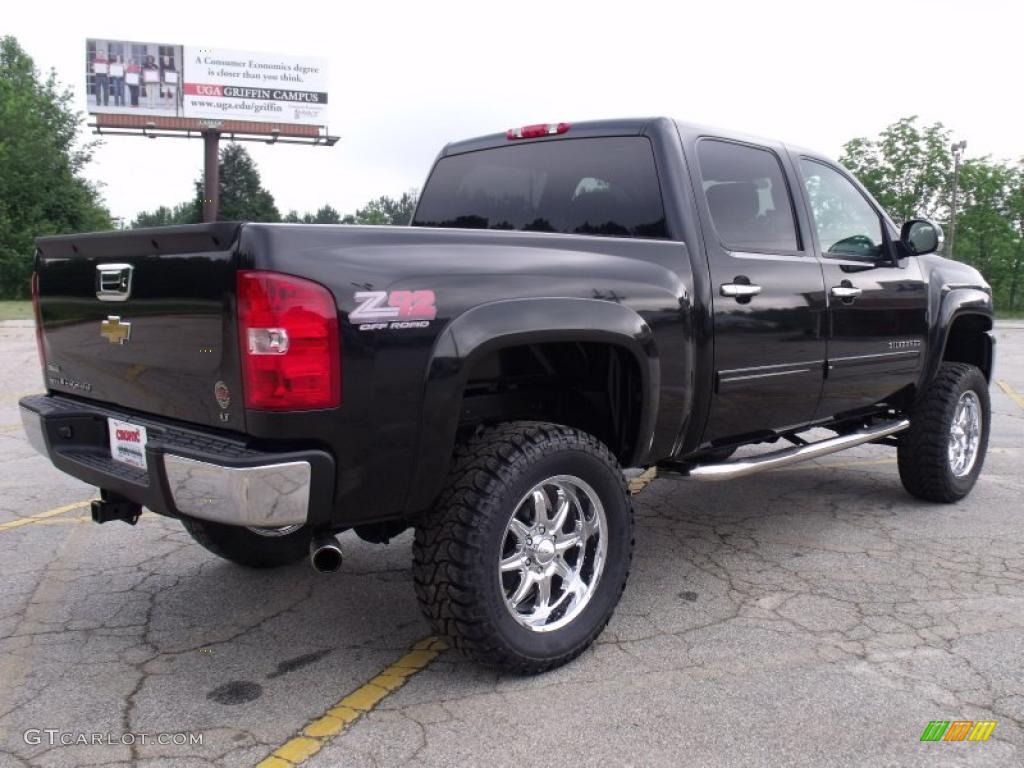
[{"x1": 498, "y1": 475, "x2": 608, "y2": 632}]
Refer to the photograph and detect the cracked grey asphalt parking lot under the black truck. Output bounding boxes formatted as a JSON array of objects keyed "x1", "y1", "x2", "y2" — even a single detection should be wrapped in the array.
[{"x1": 0, "y1": 322, "x2": 1024, "y2": 768}]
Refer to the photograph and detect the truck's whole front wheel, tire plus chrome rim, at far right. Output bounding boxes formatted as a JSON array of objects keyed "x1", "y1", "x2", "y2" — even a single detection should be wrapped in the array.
[{"x1": 897, "y1": 362, "x2": 991, "y2": 503}]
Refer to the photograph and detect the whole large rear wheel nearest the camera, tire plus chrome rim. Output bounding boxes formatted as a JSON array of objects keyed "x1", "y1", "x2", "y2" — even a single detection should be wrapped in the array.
[{"x1": 413, "y1": 422, "x2": 633, "y2": 674}]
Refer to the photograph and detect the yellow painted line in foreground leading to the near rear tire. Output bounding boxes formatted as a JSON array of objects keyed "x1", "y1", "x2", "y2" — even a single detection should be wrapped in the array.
[{"x1": 256, "y1": 637, "x2": 447, "y2": 768}]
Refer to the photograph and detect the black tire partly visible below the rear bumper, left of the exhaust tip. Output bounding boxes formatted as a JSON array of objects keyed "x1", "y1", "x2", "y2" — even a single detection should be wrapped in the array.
[{"x1": 181, "y1": 517, "x2": 312, "y2": 568}]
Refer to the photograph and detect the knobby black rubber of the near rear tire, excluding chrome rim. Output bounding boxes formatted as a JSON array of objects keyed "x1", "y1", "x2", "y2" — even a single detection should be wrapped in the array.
[{"x1": 413, "y1": 422, "x2": 633, "y2": 674}]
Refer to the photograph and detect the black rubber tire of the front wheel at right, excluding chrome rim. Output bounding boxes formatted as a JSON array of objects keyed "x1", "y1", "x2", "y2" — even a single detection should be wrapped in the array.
[{"x1": 897, "y1": 362, "x2": 991, "y2": 504}]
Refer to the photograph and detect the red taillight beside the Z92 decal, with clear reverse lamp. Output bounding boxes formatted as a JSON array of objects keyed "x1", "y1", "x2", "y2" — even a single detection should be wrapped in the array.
[{"x1": 237, "y1": 271, "x2": 341, "y2": 411}]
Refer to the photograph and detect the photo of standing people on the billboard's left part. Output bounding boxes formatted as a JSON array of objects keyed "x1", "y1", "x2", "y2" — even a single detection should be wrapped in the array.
[{"x1": 85, "y1": 38, "x2": 182, "y2": 117}]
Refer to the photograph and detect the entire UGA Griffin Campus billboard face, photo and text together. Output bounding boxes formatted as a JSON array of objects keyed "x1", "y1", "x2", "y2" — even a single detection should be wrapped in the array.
[{"x1": 86, "y1": 39, "x2": 328, "y2": 126}]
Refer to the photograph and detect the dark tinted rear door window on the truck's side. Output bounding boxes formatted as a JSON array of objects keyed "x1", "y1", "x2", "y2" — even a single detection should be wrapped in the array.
[{"x1": 697, "y1": 138, "x2": 800, "y2": 252}]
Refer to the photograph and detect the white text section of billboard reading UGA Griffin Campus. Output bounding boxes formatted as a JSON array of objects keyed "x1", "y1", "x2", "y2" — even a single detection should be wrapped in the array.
[{"x1": 181, "y1": 46, "x2": 328, "y2": 125}]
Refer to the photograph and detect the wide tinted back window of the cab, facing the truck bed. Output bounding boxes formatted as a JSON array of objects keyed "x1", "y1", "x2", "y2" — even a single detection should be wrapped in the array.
[{"x1": 413, "y1": 136, "x2": 669, "y2": 238}]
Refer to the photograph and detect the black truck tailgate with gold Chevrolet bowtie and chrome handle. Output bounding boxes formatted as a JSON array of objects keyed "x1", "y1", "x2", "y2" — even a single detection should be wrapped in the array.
[{"x1": 36, "y1": 223, "x2": 245, "y2": 431}]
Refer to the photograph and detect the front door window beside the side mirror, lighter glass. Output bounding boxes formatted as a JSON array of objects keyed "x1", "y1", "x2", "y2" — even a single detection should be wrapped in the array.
[{"x1": 800, "y1": 158, "x2": 885, "y2": 261}]
